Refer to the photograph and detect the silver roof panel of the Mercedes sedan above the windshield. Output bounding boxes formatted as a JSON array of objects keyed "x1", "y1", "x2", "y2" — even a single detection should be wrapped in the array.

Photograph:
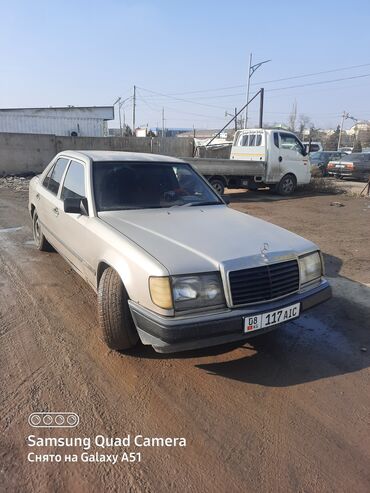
[{"x1": 60, "y1": 150, "x2": 184, "y2": 163}]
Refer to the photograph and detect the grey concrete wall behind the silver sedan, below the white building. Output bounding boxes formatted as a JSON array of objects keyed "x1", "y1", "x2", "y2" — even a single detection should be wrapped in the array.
[{"x1": 0, "y1": 133, "x2": 193, "y2": 176}]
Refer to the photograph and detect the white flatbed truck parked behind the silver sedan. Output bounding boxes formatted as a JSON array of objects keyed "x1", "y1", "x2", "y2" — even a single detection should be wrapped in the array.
[{"x1": 187, "y1": 128, "x2": 311, "y2": 195}]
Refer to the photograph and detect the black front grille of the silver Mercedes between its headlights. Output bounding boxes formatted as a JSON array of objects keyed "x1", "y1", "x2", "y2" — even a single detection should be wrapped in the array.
[{"x1": 229, "y1": 260, "x2": 299, "y2": 306}]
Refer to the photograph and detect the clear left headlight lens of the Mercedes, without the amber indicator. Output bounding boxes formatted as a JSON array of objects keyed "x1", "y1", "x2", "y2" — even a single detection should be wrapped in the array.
[{"x1": 172, "y1": 272, "x2": 225, "y2": 310}]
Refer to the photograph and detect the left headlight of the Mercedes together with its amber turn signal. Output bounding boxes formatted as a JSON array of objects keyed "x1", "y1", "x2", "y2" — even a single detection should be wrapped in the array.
[{"x1": 149, "y1": 272, "x2": 225, "y2": 311}]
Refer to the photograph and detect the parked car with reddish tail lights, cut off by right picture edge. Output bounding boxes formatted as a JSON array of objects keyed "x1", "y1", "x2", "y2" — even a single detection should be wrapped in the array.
[{"x1": 328, "y1": 152, "x2": 370, "y2": 181}]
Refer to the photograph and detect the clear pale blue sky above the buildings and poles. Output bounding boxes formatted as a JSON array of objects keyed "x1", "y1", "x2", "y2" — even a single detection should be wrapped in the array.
[{"x1": 0, "y1": 0, "x2": 370, "y2": 128}]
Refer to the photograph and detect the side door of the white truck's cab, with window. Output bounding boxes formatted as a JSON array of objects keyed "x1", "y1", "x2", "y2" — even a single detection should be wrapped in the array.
[{"x1": 279, "y1": 132, "x2": 311, "y2": 185}]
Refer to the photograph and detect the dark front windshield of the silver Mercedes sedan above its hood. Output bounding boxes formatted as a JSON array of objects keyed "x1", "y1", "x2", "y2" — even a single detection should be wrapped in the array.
[{"x1": 93, "y1": 161, "x2": 223, "y2": 212}]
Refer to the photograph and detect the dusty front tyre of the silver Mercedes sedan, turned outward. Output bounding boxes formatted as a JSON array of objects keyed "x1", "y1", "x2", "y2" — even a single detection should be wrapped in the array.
[{"x1": 98, "y1": 267, "x2": 139, "y2": 350}]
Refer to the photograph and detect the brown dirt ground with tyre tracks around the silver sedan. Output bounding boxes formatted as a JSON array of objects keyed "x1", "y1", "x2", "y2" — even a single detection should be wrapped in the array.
[{"x1": 0, "y1": 182, "x2": 370, "y2": 493}]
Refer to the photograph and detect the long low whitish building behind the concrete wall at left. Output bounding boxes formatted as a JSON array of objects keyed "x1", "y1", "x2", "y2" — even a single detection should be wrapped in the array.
[{"x1": 0, "y1": 106, "x2": 114, "y2": 137}]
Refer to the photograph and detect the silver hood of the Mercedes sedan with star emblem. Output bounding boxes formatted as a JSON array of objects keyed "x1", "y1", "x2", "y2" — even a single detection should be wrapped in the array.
[{"x1": 98, "y1": 205, "x2": 317, "y2": 274}]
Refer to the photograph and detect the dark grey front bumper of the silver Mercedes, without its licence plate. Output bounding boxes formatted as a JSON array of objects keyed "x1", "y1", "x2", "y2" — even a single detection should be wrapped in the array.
[{"x1": 129, "y1": 280, "x2": 331, "y2": 353}]
